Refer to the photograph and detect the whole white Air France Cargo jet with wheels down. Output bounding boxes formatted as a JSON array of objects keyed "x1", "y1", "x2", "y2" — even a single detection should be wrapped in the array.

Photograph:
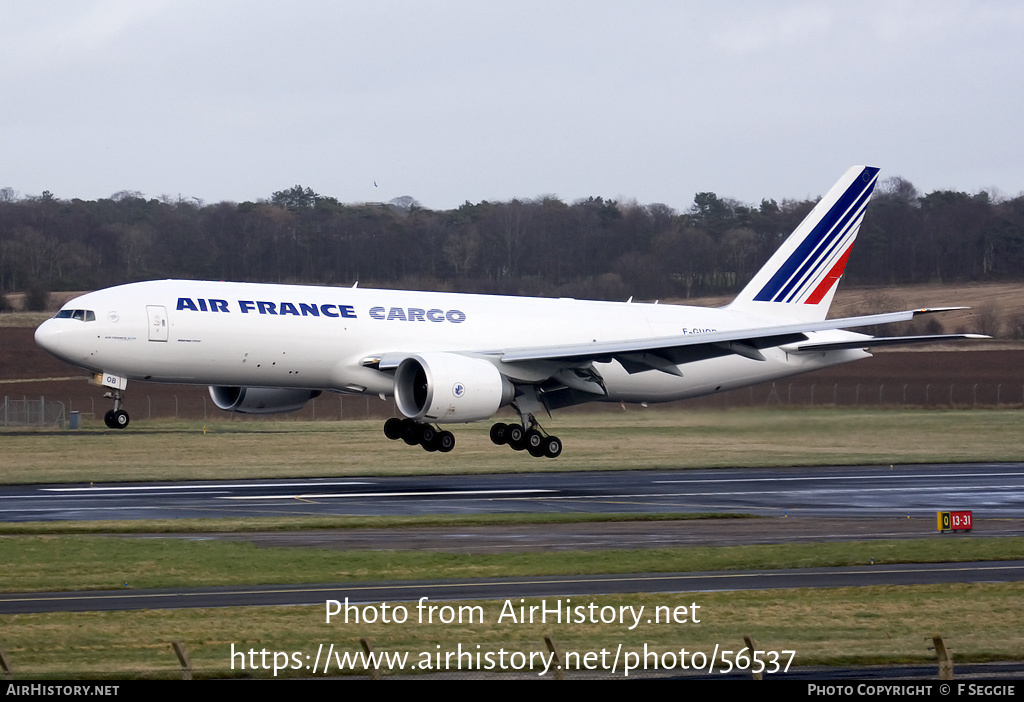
[{"x1": 36, "y1": 166, "x2": 984, "y2": 457}]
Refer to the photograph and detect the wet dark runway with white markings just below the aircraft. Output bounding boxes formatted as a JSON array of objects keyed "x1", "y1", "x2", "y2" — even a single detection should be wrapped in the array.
[{"x1": 0, "y1": 464, "x2": 1024, "y2": 522}]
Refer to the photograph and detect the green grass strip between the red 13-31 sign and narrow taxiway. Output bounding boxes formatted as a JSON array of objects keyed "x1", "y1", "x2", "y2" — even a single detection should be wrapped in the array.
[{"x1": 0, "y1": 535, "x2": 1024, "y2": 591}]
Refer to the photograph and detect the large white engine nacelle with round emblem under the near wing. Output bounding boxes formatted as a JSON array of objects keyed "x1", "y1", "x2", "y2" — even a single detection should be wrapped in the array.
[{"x1": 394, "y1": 353, "x2": 515, "y2": 422}]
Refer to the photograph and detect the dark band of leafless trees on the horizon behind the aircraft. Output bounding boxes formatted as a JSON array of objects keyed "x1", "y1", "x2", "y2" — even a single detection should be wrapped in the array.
[{"x1": 0, "y1": 178, "x2": 1024, "y2": 303}]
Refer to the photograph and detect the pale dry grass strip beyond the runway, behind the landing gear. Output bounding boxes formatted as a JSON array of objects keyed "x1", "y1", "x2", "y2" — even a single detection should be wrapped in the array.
[{"x1": 0, "y1": 408, "x2": 1024, "y2": 483}]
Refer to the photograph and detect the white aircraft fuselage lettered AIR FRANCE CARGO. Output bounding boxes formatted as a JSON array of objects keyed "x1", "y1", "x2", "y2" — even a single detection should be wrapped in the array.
[{"x1": 36, "y1": 280, "x2": 869, "y2": 413}]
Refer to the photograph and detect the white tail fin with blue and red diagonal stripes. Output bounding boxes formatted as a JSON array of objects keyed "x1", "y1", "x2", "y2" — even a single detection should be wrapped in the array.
[{"x1": 729, "y1": 166, "x2": 879, "y2": 321}]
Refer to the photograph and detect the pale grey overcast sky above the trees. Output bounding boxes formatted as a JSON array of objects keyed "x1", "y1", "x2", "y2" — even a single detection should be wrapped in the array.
[{"x1": 0, "y1": 0, "x2": 1024, "y2": 210}]
